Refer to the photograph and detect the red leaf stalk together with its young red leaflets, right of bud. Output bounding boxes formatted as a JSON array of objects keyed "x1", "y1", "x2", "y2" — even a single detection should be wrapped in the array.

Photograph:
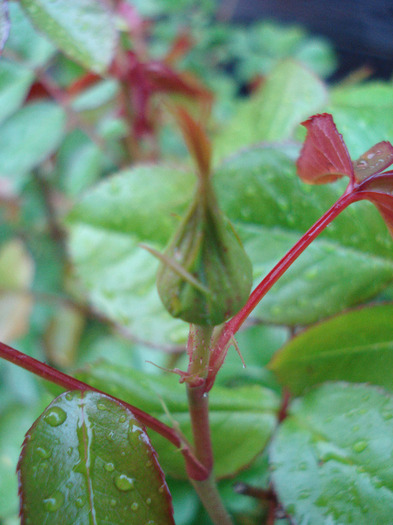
[{"x1": 205, "y1": 113, "x2": 393, "y2": 392}]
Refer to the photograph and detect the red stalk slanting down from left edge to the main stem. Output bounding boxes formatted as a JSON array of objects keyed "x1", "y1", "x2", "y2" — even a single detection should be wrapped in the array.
[{"x1": 0, "y1": 342, "x2": 209, "y2": 481}]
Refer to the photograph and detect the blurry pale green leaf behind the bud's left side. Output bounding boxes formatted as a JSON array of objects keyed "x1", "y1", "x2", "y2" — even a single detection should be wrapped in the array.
[{"x1": 69, "y1": 166, "x2": 194, "y2": 343}]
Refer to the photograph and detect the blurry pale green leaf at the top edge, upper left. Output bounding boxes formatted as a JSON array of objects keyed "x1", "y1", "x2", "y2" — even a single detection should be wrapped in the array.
[{"x1": 21, "y1": 0, "x2": 117, "y2": 73}]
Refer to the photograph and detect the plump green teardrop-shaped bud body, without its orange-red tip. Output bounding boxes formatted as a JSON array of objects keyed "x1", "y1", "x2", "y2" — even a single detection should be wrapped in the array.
[{"x1": 157, "y1": 181, "x2": 252, "y2": 326}]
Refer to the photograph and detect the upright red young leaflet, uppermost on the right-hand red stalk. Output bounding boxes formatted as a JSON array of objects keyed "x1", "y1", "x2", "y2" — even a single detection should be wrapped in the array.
[{"x1": 297, "y1": 113, "x2": 354, "y2": 184}]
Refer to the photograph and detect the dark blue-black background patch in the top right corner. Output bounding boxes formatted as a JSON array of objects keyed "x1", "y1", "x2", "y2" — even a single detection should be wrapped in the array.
[{"x1": 221, "y1": 0, "x2": 393, "y2": 79}]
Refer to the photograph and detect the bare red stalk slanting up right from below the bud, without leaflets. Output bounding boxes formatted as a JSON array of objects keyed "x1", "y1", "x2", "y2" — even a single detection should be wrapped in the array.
[{"x1": 205, "y1": 190, "x2": 359, "y2": 392}]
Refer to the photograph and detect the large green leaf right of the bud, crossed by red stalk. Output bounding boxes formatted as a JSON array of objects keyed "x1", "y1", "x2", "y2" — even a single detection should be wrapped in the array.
[{"x1": 214, "y1": 146, "x2": 393, "y2": 324}]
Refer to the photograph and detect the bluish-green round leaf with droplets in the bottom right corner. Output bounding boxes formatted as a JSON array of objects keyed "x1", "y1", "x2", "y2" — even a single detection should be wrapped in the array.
[{"x1": 270, "y1": 383, "x2": 393, "y2": 525}]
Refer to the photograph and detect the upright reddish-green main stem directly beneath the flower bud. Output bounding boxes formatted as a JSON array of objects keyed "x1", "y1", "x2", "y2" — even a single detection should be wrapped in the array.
[{"x1": 187, "y1": 325, "x2": 232, "y2": 525}]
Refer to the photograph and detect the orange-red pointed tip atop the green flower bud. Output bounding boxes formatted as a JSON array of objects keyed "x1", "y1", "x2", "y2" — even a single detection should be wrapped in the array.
[{"x1": 173, "y1": 107, "x2": 212, "y2": 177}]
